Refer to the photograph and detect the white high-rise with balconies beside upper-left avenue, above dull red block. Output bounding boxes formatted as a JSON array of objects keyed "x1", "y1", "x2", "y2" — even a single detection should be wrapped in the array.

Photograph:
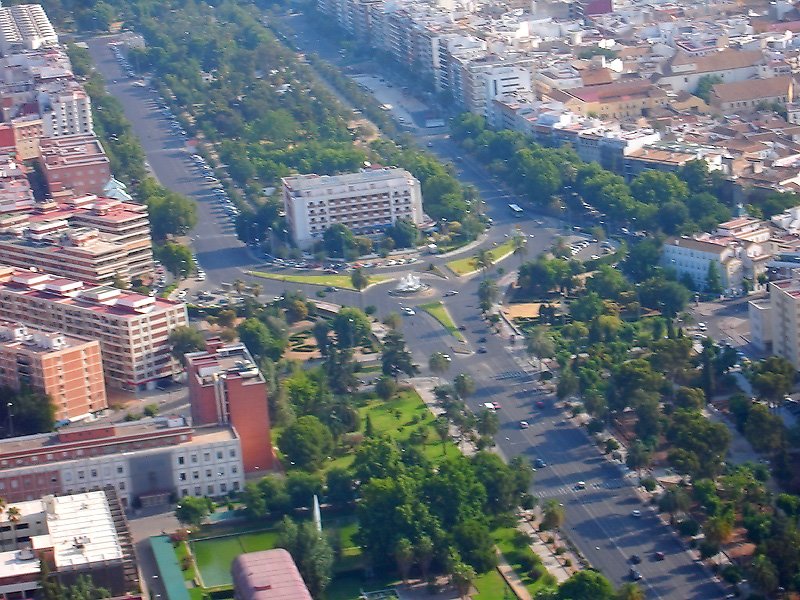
[{"x1": 37, "y1": 81, "x2": 94, "y2": 138}]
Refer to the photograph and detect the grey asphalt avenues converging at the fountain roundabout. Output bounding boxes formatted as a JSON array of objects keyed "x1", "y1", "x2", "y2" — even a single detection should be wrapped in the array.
[{"x1": 89, "y1": 25, "x2": 723, "y2": 599}]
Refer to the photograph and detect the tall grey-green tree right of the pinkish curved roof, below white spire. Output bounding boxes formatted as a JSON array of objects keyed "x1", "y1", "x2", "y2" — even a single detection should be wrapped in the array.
[{"x1": 278, "y1": 517, "x2": 333, "y2": 598}]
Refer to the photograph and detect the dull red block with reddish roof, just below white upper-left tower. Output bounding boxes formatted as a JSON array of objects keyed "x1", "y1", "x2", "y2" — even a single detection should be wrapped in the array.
[{"x1": 39, "y1": 134, "x2": 111, "y2": 196}]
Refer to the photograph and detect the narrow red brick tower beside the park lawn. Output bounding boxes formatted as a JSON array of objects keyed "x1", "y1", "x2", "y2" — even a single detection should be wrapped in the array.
[{"x1": 185, "y1": 338, "x2": 273, "y2": 473}]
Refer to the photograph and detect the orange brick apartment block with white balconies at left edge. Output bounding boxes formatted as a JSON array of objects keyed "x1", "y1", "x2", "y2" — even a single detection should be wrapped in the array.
[{"x1": 0, "y1": 320, "x2": 108, "y2": 421}]
